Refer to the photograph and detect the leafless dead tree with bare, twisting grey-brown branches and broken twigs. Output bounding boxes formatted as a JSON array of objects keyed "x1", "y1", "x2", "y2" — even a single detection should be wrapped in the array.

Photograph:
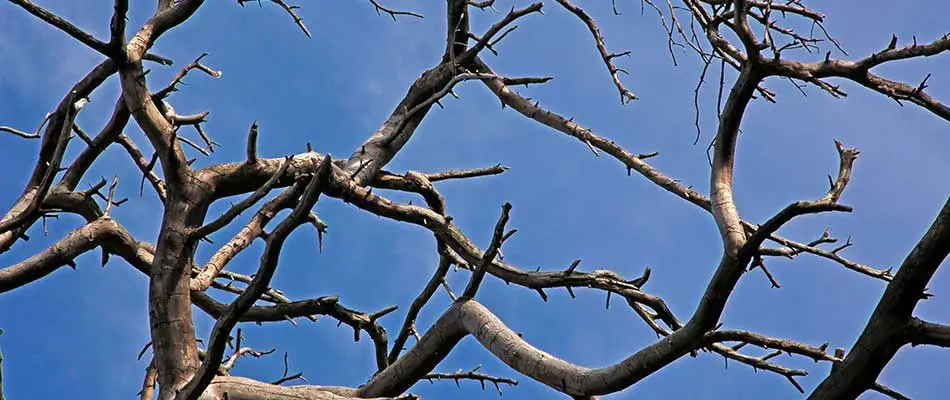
[{"x1": 0, "y1": 0, "x2": 950, "y2": 400}]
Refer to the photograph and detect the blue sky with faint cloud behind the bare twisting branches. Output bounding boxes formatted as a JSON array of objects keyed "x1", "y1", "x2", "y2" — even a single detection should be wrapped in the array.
[{"x1": 0, "y1": 0, "x2": 950, "y2": 400}]
